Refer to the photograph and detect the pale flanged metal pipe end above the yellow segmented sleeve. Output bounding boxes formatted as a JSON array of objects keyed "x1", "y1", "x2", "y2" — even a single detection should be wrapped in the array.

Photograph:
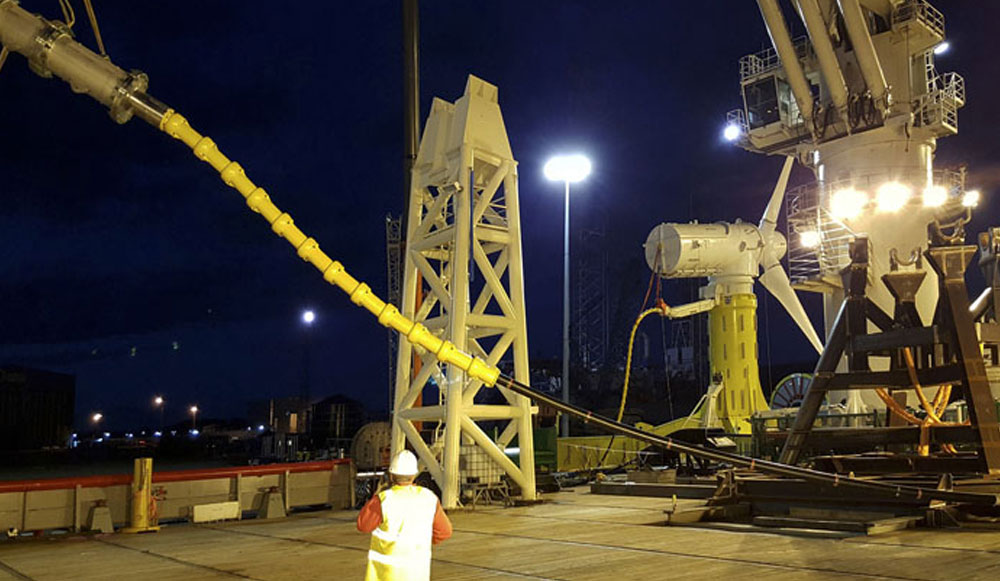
[{"x1": 0, "y1": 0, "x2": 167, "y2": 126}]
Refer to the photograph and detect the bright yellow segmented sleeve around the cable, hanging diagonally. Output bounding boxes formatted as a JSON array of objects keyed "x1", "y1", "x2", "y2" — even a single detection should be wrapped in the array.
[{"x1": 159, "y1": 109, "x2": 500, "y2": 387}]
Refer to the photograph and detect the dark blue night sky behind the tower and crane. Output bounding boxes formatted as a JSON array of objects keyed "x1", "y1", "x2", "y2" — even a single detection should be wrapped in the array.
[{"x1": 0, "y1": 0, "x2": 1000, "y2": 427}]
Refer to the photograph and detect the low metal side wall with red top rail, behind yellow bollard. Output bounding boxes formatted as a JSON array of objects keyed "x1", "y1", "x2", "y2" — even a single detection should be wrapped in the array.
[{"x1": 0, "y1": 460, "x2": 355, "y2": 532}]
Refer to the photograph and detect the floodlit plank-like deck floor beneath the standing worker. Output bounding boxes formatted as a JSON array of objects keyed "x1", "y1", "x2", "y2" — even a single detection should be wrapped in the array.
[{"x1": 0, "y1": 488, "x2": 1000, "y2": 581}]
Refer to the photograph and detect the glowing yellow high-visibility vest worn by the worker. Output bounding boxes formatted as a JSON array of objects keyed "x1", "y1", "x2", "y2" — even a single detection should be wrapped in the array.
[{"x1": 365, "y1": 485, "x2": 438, "y2": 581}]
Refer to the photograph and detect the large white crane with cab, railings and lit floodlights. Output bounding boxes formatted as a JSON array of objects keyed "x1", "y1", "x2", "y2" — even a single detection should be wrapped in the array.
[{"x1": 726, "y1": 0, "x2": 979, "y2": 411}]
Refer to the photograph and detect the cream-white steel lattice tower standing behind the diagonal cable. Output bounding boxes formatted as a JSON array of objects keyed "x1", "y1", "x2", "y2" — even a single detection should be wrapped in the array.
[{"x1": 392, "y1": 76, "x2": 535, "y2": 508}]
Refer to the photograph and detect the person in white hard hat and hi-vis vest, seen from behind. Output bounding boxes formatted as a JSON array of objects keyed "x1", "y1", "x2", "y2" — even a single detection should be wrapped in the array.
[{"x1": 358, "y1": 450, "x2": 451, "y2": 581}]
